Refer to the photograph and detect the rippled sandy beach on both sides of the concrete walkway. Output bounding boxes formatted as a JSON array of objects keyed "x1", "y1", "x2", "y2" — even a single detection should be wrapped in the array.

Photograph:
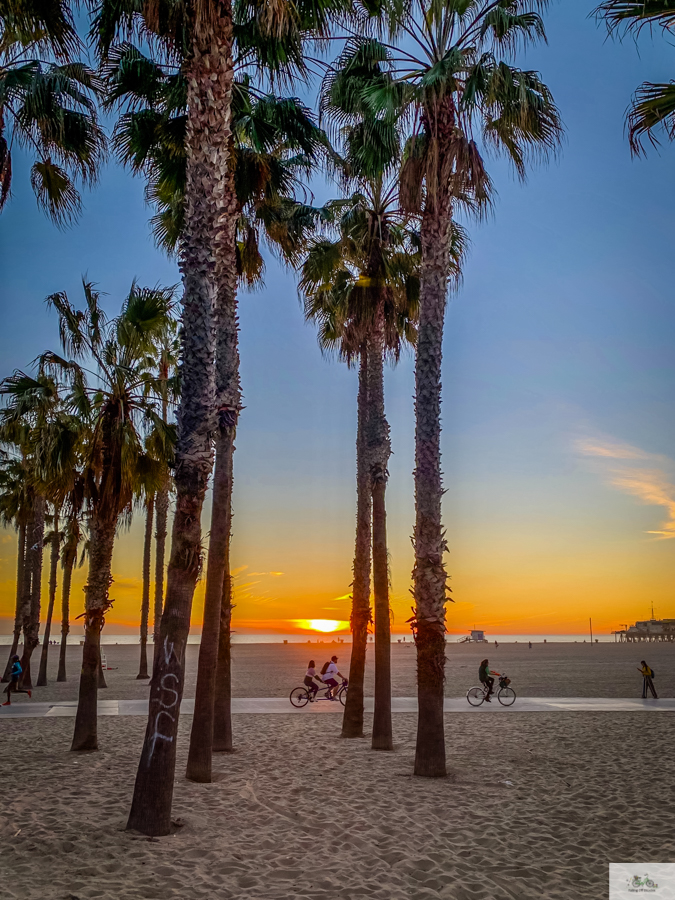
[{"x1": 0, "y1": 644, "x2": 675, "y2": 900}]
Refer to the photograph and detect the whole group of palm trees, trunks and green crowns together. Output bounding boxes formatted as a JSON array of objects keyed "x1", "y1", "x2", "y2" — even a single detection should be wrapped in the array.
[{"x1": 0, "y1": 0, "x2": 672, "y2": 835}]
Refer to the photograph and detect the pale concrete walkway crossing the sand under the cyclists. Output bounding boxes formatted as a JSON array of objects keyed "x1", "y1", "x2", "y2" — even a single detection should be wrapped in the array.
[{"x1": 0, "y1": 697, "x2": 675, "y2": 719}]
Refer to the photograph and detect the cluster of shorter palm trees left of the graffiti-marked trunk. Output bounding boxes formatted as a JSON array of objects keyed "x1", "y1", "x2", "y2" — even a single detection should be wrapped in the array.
[{"x1": 0, "y1": 282, "x2": 177, "y2": 712}]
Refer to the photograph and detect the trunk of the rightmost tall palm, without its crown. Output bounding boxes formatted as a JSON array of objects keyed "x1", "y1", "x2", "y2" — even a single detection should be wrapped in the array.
[{"x1": 413, "y1": 178, "x2": 451, "y2": 778}]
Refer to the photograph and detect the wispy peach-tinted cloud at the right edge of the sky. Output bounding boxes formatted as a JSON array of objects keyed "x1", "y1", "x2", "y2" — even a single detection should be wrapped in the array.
[{"x1": 576, "y1": 437, "x2": 675, "y2": 540}]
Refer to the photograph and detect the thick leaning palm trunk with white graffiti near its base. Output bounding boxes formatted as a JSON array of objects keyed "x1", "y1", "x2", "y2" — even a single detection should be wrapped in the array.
[{"x1": 127, "y1": 2, "x2": 233, "y2": 836}]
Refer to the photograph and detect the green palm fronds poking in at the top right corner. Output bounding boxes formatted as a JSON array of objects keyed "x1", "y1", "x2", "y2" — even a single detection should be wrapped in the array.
[{"x1": 595, "y1": 0, "x2": 675, "y2": 156}]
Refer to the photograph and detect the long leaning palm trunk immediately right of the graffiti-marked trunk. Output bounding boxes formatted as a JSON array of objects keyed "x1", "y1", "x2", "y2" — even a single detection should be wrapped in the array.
[{"x1": 187, "y1": 123, "x2": 241, "y2": 782}]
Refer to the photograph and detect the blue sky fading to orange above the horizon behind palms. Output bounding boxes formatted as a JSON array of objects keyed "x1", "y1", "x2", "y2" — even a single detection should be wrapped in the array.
[{"x1": 0, "y1": 0, "x2": 675, "y2": 632}]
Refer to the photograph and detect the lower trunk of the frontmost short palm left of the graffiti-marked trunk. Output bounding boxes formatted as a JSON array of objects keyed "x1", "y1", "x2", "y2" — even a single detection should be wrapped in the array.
[{"x1": 70, "y1": 509, "x2": 117, "y2": 750}]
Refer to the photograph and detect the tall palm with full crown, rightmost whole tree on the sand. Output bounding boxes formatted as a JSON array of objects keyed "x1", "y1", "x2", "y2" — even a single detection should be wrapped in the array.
[{"x1": 341, "y1": 0, "x2": 561, "y2": 777}]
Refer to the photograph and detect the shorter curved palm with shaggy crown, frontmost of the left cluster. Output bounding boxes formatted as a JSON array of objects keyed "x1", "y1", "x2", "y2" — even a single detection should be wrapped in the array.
[{"x1": 41, "y1": 282, "x2": 172, "y2": 750}]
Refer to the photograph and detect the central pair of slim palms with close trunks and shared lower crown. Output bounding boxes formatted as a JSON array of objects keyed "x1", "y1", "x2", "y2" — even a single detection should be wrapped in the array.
[{"x1": 300, "y1": 200, "x2": 428, "y2": 750}]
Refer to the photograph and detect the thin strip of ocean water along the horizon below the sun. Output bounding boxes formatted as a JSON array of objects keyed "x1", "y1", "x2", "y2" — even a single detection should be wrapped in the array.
[{"x1": 0, "y1": 631, "x2": 614, "y2": 646}]
